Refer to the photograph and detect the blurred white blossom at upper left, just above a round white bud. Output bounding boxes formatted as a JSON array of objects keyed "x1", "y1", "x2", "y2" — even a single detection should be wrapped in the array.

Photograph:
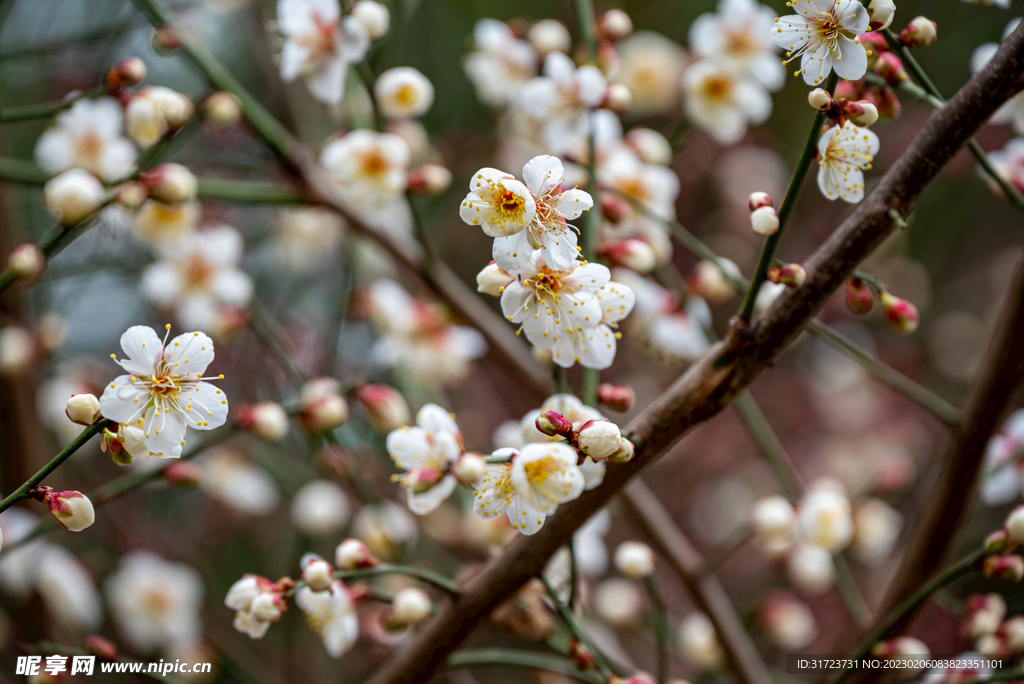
[{"x1": 35, "y1": 97, "x2": 138, "y2": 182}]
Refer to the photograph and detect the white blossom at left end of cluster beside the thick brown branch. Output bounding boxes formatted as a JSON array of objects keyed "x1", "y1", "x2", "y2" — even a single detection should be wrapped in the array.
[{"x1": 387, "y1": 403, "x2": 462, "y2": 515}]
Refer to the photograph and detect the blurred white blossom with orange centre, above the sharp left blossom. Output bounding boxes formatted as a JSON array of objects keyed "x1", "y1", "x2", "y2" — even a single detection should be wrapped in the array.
[{"x1": 141, "y1": 225, "x2": 253, "y2": 330}]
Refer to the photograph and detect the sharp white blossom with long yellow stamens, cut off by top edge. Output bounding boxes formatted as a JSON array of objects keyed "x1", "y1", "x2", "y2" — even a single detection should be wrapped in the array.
[{"x1": 771, "y1": 0, "x2": 869, "y2": 85}]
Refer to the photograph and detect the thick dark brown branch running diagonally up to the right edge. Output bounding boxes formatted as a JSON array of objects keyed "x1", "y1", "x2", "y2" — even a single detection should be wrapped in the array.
[{"x1": 362, "y1": 21, "x2": 1024, "y2": 684}]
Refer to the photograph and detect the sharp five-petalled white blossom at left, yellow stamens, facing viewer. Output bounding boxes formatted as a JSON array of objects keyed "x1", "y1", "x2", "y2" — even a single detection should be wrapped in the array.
[{"x1": 99, "y1": 326, "x2": 227, "y2": 458}]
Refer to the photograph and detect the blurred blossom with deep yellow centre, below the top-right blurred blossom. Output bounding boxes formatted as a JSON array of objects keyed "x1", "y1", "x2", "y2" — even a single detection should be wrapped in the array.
[{"x1": 683, "y1": 58, "x2": 772, "y2": 145}]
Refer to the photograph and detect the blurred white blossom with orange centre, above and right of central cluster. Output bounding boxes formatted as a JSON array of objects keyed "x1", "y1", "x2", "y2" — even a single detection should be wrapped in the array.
[{"x1": 519, "y1": 52, "x2": 608, "y2": 155}]
